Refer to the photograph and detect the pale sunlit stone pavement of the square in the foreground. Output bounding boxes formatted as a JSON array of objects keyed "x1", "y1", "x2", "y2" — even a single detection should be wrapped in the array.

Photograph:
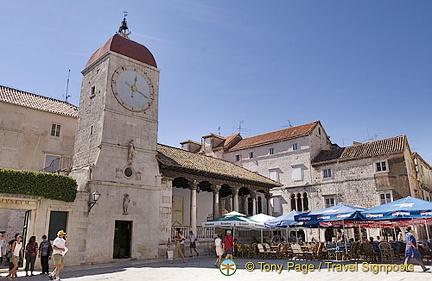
[{"x1": 0, "y1": 256, "x2": 432, "y2": 281}]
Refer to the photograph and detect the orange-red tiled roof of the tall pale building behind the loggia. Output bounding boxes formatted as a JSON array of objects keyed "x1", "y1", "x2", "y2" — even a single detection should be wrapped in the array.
[{"x1": 230, "y1": 121, "x2": 320, "y2": 151}]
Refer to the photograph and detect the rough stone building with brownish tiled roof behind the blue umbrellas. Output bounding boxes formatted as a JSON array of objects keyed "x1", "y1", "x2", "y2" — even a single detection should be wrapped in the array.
[{"x1": 312, "y1": 136, "x2": 419, "y2": 209}]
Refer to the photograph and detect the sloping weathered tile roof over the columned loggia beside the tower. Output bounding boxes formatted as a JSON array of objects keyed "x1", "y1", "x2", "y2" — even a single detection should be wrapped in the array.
[{"x1": 157, "y1": 144, "x2": 282, "y2": 187}]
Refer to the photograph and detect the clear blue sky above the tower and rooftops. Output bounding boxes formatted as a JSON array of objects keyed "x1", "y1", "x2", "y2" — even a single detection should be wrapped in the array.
[{"x1": 0, "y1": 0, "x2": 432, "y2": 164}]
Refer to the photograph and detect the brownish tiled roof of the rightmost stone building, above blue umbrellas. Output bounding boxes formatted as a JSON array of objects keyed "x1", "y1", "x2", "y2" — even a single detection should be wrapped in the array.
[{"x1": 313, "y1": 135, "x2": 408, "y2": 164}]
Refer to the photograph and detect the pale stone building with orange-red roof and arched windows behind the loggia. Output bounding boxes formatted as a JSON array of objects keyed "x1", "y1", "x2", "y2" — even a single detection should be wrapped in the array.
[{"x1": 181, "y1": 121, "x2": 331, "y2": 216}]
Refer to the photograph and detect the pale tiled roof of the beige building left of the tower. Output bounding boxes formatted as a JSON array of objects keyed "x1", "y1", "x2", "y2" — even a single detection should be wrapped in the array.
[{"x1": 0, "y1": 85, "x2": 78, "y2": 118}]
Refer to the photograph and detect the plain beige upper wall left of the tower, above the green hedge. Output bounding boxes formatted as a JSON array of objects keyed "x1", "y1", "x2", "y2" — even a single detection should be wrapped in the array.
[{"x1": 0, "y1": 102, "x2": 76, "y2": 171}]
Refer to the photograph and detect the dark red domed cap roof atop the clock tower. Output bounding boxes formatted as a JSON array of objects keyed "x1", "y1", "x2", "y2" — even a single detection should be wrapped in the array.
[{"x1": 85, "y1": 34, "x2": 157, "y2": 68}]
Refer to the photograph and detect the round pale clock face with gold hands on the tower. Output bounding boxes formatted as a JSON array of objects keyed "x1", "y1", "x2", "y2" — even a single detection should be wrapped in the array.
[{"x1": 111, "y1": 66, "x2": 153, "y2": 111}]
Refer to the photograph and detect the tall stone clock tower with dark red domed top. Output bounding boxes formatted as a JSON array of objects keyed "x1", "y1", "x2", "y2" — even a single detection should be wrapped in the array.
[{"x1": 70, "y1": 19, "x2": 161, "y2": 261}]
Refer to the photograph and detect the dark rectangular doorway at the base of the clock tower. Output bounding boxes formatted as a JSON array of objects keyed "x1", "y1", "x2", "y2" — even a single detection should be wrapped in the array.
[{"x1": 113, "y1": 221, "x2": 132, "y2": 259}]
